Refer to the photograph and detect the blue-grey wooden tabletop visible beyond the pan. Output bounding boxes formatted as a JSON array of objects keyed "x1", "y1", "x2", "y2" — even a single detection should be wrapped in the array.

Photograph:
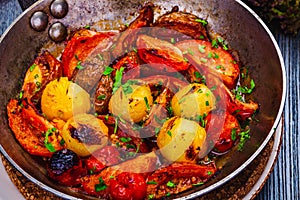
[{"x1": 0, "y1": 0, "x2": 300, "y2": 200}]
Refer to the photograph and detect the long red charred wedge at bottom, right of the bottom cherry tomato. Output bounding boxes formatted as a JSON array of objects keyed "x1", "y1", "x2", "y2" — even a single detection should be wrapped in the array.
[{"x1": 146, "y1": 163, "x2": 217, "y2": 199}]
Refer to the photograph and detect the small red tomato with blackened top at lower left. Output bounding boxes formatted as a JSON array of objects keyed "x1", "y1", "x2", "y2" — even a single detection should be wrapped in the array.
[{"x1": 47, "y1": 149, "x2": 86, "y2": 186}]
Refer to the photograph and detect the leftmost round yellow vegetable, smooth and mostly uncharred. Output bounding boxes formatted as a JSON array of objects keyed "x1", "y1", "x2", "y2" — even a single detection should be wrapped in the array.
[{"x1": 41, "y1": 77, "x2": 90, "y2": 121}]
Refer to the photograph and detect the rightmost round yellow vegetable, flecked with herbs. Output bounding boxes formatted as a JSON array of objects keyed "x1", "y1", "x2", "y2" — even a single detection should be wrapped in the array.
[{"x1": 171, "y1": 83, "x2": 216, "y2": 119}]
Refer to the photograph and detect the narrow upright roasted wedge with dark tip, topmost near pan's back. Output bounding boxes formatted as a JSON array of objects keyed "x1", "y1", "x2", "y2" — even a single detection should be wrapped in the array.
[{"x1": 112, "y1": 3, "x2": 154, "y2": 58}]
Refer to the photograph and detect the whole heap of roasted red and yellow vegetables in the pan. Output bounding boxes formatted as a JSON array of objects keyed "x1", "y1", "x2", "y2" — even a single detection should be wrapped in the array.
[{"x1": 7, "y1": 4, "x2": 259, "y2": 199}]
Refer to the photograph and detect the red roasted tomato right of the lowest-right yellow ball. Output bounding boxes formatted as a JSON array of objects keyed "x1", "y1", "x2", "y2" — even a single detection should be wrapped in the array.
[{"x1": 206, "y1": 112, "x2": 240, "y2": 153}]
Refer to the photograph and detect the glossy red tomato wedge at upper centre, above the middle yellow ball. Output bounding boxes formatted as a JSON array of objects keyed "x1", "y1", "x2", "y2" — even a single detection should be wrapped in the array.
[{"x1": 137, "y1": 35, "x2": 189, "y2": 72}]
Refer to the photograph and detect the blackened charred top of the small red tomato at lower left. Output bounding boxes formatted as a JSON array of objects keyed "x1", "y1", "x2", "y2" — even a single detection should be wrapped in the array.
[{"x1": 49, "y1": 149, "x2": 80, "y2": 175}]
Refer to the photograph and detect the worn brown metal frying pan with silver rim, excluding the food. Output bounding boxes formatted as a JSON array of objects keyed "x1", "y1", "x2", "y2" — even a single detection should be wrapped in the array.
[{"x1": 0, "y1": 0, "x2": 286, "y2": 199}]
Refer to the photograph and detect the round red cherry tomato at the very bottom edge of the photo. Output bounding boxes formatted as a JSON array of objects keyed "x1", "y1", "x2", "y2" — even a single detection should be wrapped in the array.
[{"x1": 109, "y1": 172, "x2": 147, "y2": 200}]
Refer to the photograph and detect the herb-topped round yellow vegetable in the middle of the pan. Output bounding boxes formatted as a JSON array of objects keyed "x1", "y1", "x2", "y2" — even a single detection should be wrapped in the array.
[{"x1": 109, "y1": 84, "x2": 153, "y2": 123}]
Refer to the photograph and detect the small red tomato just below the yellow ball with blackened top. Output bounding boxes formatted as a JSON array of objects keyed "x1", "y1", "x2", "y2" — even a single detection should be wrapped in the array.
[{"x1": 85, "y1": 146, "x2": 121, "y2": 174}]
